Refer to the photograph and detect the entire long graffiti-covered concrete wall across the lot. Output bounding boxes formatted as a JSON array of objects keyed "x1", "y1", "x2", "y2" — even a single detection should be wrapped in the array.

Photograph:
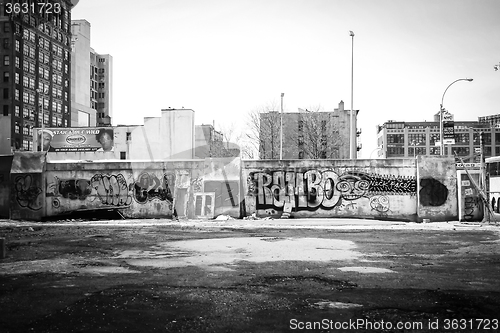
[{"x1": 5, "y1": 153, "x2": 462, "y2": 221}]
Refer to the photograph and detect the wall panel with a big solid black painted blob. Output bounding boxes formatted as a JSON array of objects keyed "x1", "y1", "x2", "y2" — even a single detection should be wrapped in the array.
[{"x1": 417, "y1": 156, "x2": 458, "y2": 221}]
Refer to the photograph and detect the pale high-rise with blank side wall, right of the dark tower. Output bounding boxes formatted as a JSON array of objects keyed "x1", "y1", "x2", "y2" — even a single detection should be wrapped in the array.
[{"x1": 71, "y1": 20, "x2": 113, "y2": 127}]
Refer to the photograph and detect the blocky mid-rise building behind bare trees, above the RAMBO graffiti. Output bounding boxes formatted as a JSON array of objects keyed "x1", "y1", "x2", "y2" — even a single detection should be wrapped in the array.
[{"x1": 259, "y1": 101, "x2": 361, "y2": 159}]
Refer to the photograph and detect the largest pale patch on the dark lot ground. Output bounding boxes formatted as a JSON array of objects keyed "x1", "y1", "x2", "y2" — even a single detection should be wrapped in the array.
[{"x1": 115, "y1": 237, "x2": 361, "y2": 270}]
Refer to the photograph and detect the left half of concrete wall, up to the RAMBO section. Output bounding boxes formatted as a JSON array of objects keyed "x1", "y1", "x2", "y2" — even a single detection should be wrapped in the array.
[{"x1": 11, "y1": 153, "x2": 240, "y2": 220}]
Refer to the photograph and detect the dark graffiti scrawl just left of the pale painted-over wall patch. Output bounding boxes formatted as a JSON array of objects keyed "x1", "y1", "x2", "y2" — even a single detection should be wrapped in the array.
[{"x1": 132, "y1": 172, "x2": 175, "y2": 204}]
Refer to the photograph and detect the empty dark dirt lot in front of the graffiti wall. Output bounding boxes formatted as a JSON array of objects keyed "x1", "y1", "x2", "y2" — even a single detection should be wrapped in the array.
[{"x1": 0, "y1": 220, "x2": 500, "y2": 332}]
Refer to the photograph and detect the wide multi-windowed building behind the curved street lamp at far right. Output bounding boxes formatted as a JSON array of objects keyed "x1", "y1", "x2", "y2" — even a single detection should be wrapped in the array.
[{"x1": 372, "y1": 113, "x2": 500, "y2": 162}]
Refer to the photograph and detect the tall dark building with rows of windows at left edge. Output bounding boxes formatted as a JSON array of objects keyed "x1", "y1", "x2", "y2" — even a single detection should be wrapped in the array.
[{"x1": 0, "y1": 0, "x2": 78, "y2": 154}]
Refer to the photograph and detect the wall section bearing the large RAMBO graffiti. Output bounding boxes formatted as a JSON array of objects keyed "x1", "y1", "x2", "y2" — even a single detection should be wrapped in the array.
[{"x1": 242, "y1": 160, "x2": 417, "y2": 220}]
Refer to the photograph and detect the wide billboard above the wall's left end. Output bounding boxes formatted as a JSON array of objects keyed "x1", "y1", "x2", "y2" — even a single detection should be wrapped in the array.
[{"x1": 34, "y1": 127, "x2": 114, "y2": 153}]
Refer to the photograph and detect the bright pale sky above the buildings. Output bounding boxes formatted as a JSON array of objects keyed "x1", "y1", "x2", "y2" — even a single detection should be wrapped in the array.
[{"x1": 72, "y1": 0, "x2": 500, "y2": 158}]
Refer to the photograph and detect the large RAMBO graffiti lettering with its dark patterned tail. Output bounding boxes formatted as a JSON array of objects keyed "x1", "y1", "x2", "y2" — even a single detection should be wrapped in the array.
[{"x1": 247, "y1": 170, "x2": 417, "y2": 213}]
